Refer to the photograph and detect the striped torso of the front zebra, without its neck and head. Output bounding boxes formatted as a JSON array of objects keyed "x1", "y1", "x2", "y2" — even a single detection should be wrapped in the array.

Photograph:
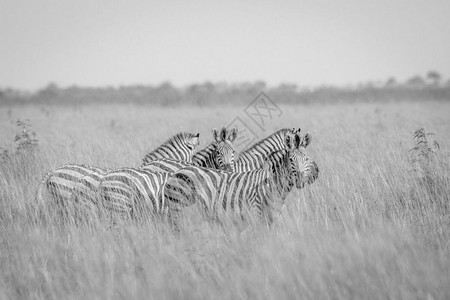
[{"x1": 164, "y1": 166, "x2": 270, "y2": 219}]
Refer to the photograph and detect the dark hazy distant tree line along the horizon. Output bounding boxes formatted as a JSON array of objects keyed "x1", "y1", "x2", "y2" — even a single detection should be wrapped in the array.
[{"x1": 0, "y1": 71, "x2": 450, "y2": 106}]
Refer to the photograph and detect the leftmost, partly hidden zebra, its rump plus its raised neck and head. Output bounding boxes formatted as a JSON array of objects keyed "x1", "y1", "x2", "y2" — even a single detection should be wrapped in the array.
[{"x1": 37, "y1": 132, "x2": 200, "y2": 214}]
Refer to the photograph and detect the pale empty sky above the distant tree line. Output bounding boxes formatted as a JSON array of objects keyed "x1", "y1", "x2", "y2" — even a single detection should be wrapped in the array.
[{"x1": 0, "y1": 0, "x2": 450, "y2": 90}]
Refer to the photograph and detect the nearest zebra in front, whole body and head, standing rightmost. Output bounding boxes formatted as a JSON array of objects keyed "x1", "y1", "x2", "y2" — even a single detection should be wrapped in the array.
[{"x1": 164, "y1": 132, "x2": 318, "y2": 225}]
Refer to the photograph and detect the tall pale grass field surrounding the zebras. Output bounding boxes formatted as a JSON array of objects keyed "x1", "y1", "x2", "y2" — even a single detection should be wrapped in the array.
[{"x1": 0, "y1": 101, "x2": 450, "y2": 299}]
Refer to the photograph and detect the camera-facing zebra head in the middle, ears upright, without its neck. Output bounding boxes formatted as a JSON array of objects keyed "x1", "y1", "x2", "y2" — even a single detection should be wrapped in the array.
[{"x1": 212, "y1": 127, "x2": 238, "y2": 171}]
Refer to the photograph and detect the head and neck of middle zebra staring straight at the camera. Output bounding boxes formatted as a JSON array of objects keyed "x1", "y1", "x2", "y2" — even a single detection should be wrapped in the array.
[{"x1": 192, "y1": 127, "x2": 238, "y2": 171}]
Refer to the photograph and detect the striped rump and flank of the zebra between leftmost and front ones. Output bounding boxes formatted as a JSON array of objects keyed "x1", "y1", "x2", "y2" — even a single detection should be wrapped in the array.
[{"x1": 98, "y1": 168, "x2": 168, "y2": 218}]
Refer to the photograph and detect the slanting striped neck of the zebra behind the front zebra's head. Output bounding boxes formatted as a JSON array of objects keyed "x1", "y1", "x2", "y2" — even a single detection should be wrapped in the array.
[{"x1": 234, "y1": 128, "x2": 300, "y2": 172}]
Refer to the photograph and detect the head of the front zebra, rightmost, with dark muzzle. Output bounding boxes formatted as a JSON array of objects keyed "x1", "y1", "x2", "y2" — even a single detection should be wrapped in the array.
[{"x1": 285, "y1": 130, "x2": 312, "y2": 188}]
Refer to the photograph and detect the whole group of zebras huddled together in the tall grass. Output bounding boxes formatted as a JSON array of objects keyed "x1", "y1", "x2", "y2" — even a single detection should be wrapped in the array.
[{"x1": 37, "y1": 128, "x2": 319, "y2": 224}]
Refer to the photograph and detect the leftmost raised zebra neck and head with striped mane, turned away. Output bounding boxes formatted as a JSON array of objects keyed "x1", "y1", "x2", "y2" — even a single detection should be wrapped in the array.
[{"x1": 142, "y1": 132, "x2": 200, "y2": 166}]
